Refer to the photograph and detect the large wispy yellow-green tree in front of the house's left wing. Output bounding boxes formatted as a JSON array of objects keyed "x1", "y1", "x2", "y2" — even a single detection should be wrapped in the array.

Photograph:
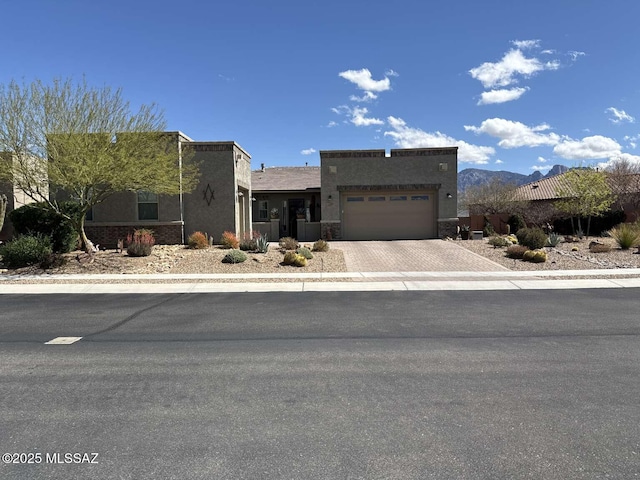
[{"x1": 0, "y1": 79, "x2": 198, "y2": 251}]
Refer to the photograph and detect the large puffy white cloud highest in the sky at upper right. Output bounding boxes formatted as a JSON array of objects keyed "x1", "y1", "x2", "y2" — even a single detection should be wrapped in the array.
[{"x1": 469, "y1": 49, "x2": 560, "y2": 88}]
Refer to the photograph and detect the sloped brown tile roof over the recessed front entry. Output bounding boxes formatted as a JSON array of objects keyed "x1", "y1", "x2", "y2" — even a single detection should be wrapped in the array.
[{"x1": 251, "y1": 167, "x2": 320, "y2": 192}]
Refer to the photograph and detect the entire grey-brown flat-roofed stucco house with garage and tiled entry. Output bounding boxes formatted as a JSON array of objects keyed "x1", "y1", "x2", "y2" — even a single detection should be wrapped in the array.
[{"x1": 0, "y1": 132, "x2": 458, "y2": 247}]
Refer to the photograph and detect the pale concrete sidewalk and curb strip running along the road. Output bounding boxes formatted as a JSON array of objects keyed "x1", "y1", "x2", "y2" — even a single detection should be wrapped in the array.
[{"x1": 0, "y1": 269, "x2": 640, "y2": 294}]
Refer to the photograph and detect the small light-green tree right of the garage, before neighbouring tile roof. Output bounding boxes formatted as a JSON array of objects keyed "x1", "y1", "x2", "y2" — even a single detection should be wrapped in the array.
[{"x1": 556, "y1": 168, "x2": 615, "y2": 236}]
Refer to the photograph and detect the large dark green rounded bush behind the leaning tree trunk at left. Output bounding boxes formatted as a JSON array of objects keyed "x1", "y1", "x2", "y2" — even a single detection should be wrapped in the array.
[{"x1": 9, "y1": 202, "x2": 79, "y2": 253}]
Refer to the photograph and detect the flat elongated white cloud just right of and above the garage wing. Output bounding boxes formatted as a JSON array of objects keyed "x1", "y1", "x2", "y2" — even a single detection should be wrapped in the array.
[{"x1": 464, "y1": 118, "x2": 560, "y2": 148}]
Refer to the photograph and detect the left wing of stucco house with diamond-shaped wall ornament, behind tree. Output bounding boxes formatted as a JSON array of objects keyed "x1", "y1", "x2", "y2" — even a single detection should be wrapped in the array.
[{"x1": 85, "y1": 132, "x2": 251, "y2": 246}]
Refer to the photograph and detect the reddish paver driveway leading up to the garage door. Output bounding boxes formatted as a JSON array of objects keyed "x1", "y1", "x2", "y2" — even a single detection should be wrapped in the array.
[{"x1": 331, "y1": 239, "x2": 508, "y2": 272}]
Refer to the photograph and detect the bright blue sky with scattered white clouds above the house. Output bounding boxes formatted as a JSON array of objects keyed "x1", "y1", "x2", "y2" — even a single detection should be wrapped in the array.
[{"x1": 5, "y1": 0, "x2": 640, "y2": 174}]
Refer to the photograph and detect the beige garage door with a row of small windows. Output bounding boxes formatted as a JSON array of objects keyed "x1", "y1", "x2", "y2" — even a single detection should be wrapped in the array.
[{"x1": 341, "y1": 191, "x2": 437, "y2": 240}]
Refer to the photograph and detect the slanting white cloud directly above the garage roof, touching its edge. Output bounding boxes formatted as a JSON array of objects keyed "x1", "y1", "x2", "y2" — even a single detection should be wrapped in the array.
[{"x1": 384, "y1": 117, "x2": 495, "y2": 164}]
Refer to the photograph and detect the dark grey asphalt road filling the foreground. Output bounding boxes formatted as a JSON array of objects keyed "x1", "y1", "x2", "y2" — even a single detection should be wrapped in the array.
[{"x1": 0, "y1": 289, "x2": 640, "y2": 479}]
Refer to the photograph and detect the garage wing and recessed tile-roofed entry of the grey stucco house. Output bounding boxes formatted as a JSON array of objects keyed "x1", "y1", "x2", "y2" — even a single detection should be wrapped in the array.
[{"x1": 251, "y1": 147, "x2": 458, "y2": 241}]
